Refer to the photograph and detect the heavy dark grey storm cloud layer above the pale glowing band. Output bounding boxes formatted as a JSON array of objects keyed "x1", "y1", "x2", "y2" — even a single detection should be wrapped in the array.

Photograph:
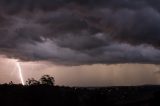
[{"x1": 0, "y1": 0, "x2": 160, "y2": 65}]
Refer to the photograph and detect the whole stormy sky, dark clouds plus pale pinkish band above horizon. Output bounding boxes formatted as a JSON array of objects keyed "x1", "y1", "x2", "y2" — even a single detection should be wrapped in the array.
[{"x1": 0, "y1": 0, "x2": 160, "y2": 86}]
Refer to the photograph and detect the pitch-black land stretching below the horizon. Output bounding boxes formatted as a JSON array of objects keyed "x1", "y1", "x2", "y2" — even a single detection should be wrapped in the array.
[{"x1": 0, "y1": 85, "x2": 160, "y2": 106}]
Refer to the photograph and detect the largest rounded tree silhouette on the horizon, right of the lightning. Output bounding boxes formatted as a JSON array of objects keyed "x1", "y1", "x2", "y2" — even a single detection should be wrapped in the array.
[{"x1": 40, "y1": 75, "x2": 55, "y2": 85}]
